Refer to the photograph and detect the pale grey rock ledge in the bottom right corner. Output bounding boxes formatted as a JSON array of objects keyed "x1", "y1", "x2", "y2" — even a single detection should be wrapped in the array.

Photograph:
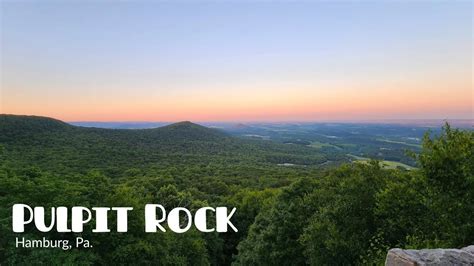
[{"x1": 385, "y1": 245, "x2": 474, "y2": 266}]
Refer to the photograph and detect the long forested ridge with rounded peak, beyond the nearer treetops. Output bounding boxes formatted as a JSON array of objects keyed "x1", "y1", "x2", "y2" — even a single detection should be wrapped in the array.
[{"x1": 0, "y1": 115, "x2": 326, "y2": 176}]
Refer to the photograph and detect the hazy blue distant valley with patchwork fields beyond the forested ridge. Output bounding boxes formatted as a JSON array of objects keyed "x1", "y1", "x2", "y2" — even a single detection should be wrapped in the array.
[{"x1": 72, "y1": 121, "x2": 456, "y2": 168}]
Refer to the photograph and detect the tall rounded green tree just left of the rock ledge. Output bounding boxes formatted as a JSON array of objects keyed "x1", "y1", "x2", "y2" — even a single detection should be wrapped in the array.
[{"x1": 300, "y1": 161, "x2": 392, "y2": 265}]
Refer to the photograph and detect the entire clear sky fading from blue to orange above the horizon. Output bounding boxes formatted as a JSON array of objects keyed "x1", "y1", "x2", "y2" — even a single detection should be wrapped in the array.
[{"x1": 0, "y1": 0, "x2": 474, "y2": 122}]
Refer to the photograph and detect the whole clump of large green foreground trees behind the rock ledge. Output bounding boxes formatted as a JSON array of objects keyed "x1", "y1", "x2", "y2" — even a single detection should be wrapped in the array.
[{"x1": 232, "y1": 125, "x2": 474, "y2": 265}]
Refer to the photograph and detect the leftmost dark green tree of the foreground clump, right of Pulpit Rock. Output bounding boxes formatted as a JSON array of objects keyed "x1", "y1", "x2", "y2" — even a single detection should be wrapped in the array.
[{"x1": 236, "y1": 178, "x2": 315, "y2": 265}]
